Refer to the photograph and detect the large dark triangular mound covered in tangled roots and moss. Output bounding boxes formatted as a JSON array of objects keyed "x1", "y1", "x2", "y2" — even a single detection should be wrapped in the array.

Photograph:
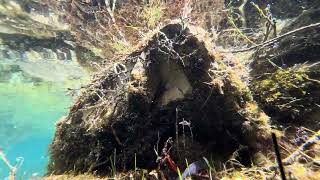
[{"x1": 48, "y1": 23, "x2": 271, "y2": 175}]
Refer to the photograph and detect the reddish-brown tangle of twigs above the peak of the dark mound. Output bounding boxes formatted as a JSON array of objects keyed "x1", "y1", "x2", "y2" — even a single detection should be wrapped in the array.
[{"x1": 47, "y1": 0, "x2": 224, "y2": 65}]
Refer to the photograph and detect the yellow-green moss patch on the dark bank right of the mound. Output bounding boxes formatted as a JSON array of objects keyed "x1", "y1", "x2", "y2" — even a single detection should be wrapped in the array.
[{"x1": 251, "y1": 65, "x2": 319, "y2": 115}]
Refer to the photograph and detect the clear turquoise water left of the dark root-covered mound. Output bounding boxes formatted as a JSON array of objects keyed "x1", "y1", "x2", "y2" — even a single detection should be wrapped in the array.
[{"x1": 0, "y1": 63, "x2": 85, "y2": 180}]
